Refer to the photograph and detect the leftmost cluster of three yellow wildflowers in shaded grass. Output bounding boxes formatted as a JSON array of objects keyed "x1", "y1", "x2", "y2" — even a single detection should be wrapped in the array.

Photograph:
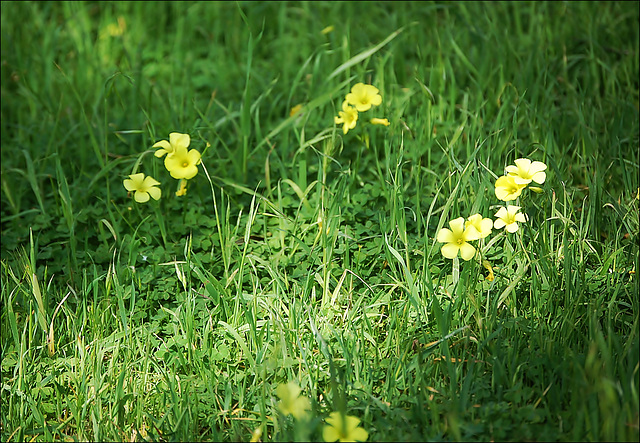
[{"x1": 123, "y1": 132, "x2": 201, "y2": 203}]
